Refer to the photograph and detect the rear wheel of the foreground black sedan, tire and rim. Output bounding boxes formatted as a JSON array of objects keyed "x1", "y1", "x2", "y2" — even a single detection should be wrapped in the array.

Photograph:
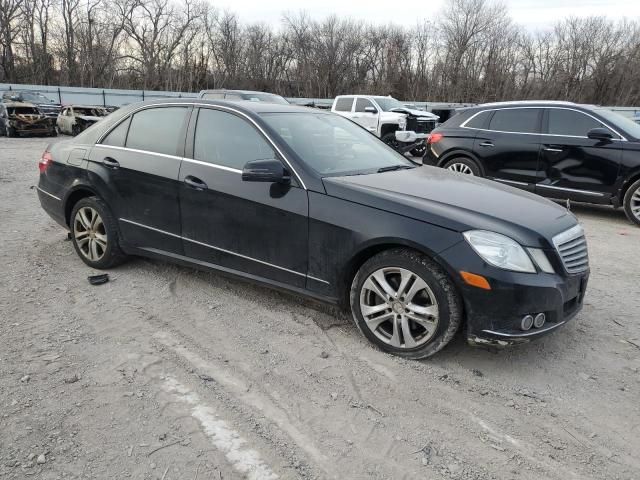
[{"x1": 69, "y1": 197, "x2": 127, "y2": 270}]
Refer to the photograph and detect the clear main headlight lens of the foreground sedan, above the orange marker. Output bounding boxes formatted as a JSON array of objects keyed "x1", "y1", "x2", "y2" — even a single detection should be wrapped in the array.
[{"x1": 463, "y1": 230, "x2": 536, "y2": 273}]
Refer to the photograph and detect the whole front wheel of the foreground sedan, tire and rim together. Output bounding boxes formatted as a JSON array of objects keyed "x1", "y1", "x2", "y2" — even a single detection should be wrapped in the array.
[{"x1": 350, "y1": 248, "x2": 463, "y2": 360}]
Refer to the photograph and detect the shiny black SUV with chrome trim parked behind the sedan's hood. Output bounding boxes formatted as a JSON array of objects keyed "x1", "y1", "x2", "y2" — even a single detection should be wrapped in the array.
[{"x1": 424, "y1": 101, "x2": 640, "y2": 225}]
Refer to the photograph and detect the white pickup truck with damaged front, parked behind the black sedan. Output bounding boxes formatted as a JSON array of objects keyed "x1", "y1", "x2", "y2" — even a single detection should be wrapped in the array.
[{"x1": 331, "y1": 95, "x2": 438, "y2": 156}]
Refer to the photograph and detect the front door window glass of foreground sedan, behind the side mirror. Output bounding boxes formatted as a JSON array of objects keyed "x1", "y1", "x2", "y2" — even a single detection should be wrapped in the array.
[{"x1": 193, "y1": 108, "x2": 276, "y2": 170}]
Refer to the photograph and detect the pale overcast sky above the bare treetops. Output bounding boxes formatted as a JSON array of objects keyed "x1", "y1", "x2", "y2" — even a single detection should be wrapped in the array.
[{"x1": 212, "y1": 0, "x2": 640, "y2": 30}]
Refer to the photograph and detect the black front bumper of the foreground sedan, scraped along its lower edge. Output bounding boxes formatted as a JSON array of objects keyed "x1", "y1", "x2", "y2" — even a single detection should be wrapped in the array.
[{"x1": 442, "y1": 242, "x2": 589, "y2": 347}]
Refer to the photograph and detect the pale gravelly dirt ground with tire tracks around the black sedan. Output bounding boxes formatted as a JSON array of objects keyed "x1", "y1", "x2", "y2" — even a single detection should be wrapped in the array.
[{"x1": 0, "y1": 138, "x2": 640, "y2": 480}]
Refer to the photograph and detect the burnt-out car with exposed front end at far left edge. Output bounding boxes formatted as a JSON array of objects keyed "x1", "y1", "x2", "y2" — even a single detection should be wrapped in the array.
[{"x1": 0, "y1": 102, "x2": 57, "y2": 137}]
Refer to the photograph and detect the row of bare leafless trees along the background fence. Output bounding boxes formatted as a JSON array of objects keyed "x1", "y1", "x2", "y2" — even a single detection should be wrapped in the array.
[{"x1": 0, "y1": 0, "x2": 640, "y2": 105}]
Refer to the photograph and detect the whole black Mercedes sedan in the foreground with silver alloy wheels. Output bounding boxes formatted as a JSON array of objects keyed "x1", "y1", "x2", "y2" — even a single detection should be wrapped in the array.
[{"x1": 37, "y1": 99, "x2": 589, "y2": 358}]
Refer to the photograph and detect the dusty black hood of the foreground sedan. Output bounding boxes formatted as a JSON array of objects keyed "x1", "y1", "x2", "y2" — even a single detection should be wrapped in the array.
[{"x1": 323, "y1": 166, "x2": 577, "y2": 248}]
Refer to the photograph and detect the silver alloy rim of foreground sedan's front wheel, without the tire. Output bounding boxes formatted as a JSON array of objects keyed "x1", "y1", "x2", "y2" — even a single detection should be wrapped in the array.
[{"x1": 360, "y1": 267, "x2": 438, "y2": 348}]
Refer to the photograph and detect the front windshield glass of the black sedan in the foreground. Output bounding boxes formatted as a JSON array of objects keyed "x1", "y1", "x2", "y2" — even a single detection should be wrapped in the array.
[{"x1": 262, "y1": 112, "x2": 415, "y2": 177}]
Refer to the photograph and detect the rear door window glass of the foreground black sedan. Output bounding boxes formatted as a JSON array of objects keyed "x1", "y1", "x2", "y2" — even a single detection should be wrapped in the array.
[{"x1": 126, "y1": 107, "x2": 188, "y2": 155}]
